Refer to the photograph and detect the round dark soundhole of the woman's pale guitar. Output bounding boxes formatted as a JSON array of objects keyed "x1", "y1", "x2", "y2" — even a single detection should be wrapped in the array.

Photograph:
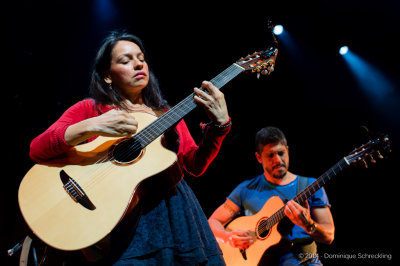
[{"x1": 112, "y1": 138, "x2": 144, "y2": 165}]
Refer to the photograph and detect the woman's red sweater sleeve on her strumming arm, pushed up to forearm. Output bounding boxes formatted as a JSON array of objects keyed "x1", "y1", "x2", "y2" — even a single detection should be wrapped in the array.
[{"x1": 29, "y1": 99, "x2": 95, "y2": 162}]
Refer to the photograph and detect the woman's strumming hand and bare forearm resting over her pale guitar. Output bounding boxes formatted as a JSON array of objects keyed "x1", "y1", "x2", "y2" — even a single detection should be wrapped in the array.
[{"x1": 64, "y1": 109, "x2": 138, "y2": 146}]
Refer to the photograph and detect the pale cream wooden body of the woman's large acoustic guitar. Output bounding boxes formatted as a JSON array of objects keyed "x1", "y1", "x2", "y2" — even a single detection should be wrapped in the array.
[{"x1": 18, "y1": 113, "x2": 182, "y2": 250}]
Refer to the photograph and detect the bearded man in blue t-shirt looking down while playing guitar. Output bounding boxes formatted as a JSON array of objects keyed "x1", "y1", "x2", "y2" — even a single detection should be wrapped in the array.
[{"x1": 209, "y1": 127, "x2": 335, "y2": 265}]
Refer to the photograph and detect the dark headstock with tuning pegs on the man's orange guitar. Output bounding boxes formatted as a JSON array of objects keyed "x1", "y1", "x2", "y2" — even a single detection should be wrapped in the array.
[{"x1": 345, "y1": 135, "x2": 391, "y2": 168}]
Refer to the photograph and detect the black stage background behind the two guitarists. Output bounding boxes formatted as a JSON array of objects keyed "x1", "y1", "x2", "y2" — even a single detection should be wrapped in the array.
[{"x1": 0, "y1": 0, "x2": 400, "y2": 265}]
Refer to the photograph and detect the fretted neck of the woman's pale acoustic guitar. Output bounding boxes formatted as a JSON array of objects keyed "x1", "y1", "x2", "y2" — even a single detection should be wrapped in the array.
[{"x1": 135, "y1": 63, "x2": 245, "y2": 147}]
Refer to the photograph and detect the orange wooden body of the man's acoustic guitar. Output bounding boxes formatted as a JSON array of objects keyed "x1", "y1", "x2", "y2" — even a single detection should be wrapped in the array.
[{"x1": 219, "y1": 196, "x2": 284, "y2": 266}]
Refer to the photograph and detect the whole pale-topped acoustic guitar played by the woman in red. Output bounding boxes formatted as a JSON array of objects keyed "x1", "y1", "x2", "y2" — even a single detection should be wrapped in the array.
[{"x1": 18, "y1": 46, "x2": 278, "y2": 250}]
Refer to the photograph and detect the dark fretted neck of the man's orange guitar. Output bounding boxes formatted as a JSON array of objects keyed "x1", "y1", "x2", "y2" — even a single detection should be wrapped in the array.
[{"x1": 264, "y1": 158, "x2": 349, "y2": 230}]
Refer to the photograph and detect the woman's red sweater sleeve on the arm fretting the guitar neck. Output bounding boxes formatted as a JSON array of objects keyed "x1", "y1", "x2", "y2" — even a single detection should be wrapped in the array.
[{"x1": 176, "y1": 120, "x2": 231, "y2": 176}]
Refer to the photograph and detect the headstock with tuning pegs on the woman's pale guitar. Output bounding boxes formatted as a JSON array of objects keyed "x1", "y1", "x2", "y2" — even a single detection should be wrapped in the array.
[{"x1": 236, "y1": 46, "x2": 278, "y2": 77}]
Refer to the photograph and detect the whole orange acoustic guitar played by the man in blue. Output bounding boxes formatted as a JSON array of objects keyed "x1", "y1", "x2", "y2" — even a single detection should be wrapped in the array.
[{"x1": 219, "y1": 136, "x2": 390, "y2": 266}]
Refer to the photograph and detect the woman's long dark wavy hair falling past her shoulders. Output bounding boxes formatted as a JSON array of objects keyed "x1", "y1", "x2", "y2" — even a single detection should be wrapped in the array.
[{"x1": 89, "y1": 31, "x2": 168, "y2": 110}]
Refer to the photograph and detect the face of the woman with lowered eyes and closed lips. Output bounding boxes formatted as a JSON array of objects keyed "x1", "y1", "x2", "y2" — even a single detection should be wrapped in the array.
[{"x1": 105, "y1": 41, "x2": 149, "y2": 99}]
